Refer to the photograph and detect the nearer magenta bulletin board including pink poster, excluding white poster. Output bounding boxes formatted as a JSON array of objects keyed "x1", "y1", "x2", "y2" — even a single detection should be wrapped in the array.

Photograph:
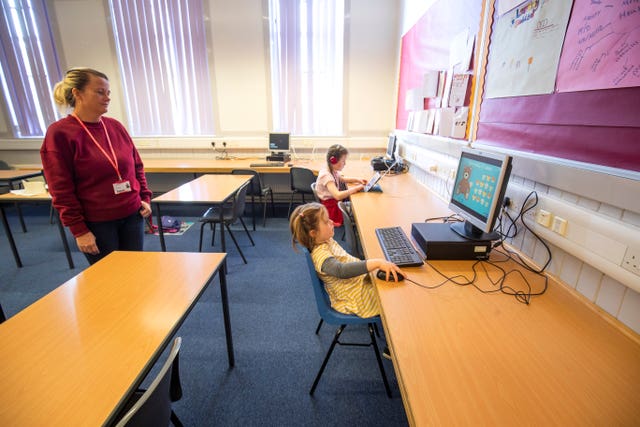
[{"x1": 476, "y1": 0, "x2": 640, "y2": 172}]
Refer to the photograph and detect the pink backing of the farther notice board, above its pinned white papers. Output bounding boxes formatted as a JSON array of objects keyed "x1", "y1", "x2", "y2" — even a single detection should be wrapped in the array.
[{"x1": 396, "y1": 0, "x2": 482, "y2": 129}]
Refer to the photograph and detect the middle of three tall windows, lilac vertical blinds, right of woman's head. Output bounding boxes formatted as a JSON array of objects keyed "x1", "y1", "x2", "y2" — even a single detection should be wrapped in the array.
[{"x1": 109, "y1": 0, "x2": 214, "y2": 136}]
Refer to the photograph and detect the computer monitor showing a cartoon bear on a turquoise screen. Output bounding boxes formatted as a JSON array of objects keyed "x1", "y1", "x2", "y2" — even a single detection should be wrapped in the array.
[{"x1": 449, "y1": 148, "x2": 511, "y2": 240}]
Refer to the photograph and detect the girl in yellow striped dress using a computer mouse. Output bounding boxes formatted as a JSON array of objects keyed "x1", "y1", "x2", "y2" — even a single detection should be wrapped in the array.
[{"x1": 289, "y1": 203, "x2": 402, "y2": 317}]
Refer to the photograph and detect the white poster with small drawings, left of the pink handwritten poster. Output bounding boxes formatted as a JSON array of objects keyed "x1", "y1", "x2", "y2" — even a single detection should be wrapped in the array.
[{"x1": 485, "y1": 0, "x2": 571, "y2": 98}]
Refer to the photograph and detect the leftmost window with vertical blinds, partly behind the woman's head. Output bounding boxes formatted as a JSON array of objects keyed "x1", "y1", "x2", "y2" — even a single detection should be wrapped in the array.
[{"x1": 0, "y1": 0, "x2": 62, "y2": 138}]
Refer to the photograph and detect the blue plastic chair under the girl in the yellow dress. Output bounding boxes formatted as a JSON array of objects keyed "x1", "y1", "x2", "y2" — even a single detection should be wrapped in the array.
[{"x1": 305, "y1": 251, "x2": 391, "y2": 397}]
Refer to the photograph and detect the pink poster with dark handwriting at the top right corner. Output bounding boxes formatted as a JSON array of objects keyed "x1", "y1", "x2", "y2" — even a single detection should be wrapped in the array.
[{"x1": 557, "y1": 0, "x2": 640, "y2": 92}]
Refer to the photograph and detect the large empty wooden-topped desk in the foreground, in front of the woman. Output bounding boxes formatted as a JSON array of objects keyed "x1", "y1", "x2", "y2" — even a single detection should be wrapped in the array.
[{"x1": 0, "y1": 252, "x2": 233, "y2": 426}]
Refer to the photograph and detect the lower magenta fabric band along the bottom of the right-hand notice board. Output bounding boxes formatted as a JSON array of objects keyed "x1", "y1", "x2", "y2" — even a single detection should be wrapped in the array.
[{"x1": 477, "y1": 123, "x2": 640, "y2": 171}]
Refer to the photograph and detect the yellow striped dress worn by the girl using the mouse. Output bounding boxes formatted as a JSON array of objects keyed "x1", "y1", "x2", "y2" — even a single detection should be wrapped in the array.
[{"x1": 311, "y1": 239, "x2": 380, "y2": 317}]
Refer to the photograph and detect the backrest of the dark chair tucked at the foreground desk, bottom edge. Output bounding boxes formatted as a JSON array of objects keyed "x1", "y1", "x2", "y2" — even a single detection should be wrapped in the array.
[{"x1": 116, "y1": 337, "x2": 182, "y2": 427}]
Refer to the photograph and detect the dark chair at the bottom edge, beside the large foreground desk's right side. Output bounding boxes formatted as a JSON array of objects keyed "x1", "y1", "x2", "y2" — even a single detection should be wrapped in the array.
[{"x1": 116, "y1": 337, "x2": 182, "y2": 427}]
